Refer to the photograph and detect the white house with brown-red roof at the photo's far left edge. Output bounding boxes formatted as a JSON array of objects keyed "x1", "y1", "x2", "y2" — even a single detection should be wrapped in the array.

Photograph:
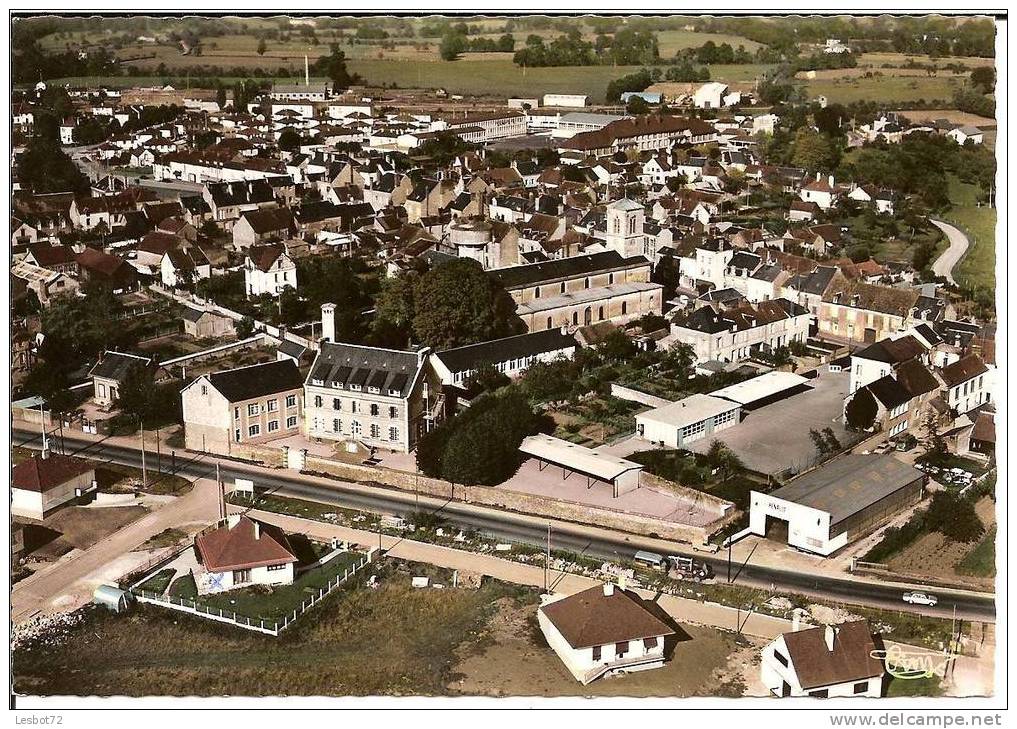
[{"x1": 10, "y1": 449, "x2": 96, "y2": 520}]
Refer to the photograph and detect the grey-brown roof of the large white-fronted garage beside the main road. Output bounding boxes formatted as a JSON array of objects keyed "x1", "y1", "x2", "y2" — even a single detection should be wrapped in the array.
[{"x1": 770, "y1": 453, "x2": 924, "y2": 533}]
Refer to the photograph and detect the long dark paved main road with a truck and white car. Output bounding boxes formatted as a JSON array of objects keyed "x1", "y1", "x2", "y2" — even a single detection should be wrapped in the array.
[{"x1": 13, "y1": 430, "x2": 996, "y2": 621}]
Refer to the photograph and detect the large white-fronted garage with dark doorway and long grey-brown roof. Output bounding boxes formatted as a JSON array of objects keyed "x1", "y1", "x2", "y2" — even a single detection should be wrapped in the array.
[{"x1": 749, "y1": 453, "x2": 925, "y2": 556}]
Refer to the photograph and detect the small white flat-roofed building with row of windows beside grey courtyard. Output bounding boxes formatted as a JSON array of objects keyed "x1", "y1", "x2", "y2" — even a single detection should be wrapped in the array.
[{"x1": 636, "y1": 393, "x2": 741, "y2": 448}]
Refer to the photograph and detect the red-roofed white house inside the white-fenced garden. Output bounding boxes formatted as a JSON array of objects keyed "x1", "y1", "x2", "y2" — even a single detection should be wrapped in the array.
[{"x1": 194, "y1": 514, "x2": 297, "y2": 595}]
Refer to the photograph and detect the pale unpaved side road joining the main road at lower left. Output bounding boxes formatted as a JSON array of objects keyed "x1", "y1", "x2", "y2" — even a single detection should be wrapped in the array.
[{"x1": 10, "y1": 481, "x2": 218, "y2": 622}]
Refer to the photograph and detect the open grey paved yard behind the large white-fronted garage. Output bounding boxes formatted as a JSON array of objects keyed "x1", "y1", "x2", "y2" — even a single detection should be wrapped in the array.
[{"x1": 690, "y1": 369, "x2": 850, "y2": 475}]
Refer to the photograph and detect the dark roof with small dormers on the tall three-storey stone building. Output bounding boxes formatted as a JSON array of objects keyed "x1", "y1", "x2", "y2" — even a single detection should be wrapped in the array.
[{"x1": 307, "y1": 342, "x2": 423, "y2": 398}]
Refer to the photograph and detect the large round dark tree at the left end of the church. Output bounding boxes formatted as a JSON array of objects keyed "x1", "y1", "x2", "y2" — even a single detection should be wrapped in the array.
[{"x1": 413, "y1": 258, "x2": 525, "y2": 350}]
